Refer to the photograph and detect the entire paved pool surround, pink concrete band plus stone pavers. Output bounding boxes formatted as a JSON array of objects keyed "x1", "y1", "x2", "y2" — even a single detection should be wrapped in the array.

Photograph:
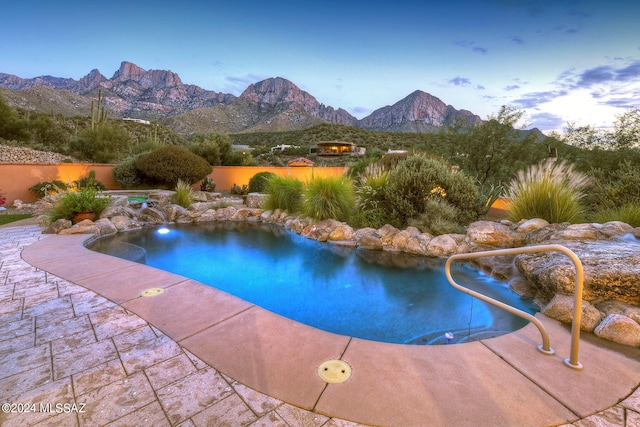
[{"x1": 0, "y1": 222, "x2": 640, "y2": 426}]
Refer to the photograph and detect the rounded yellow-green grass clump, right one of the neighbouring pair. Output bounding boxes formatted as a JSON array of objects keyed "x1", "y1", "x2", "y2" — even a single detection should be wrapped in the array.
[{"x1": 302, "y1": 176, "x2": 355, "y2": 221}]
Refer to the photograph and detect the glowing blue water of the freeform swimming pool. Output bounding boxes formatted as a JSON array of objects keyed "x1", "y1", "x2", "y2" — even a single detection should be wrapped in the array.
[{"x1": 90, "y1": 222, "x2": 537, "y2": 344}]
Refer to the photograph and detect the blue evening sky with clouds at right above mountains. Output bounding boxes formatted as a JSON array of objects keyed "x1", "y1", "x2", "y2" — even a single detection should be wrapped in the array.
[{"x1": 0, "y1": 0, "x2": 640, "y2": 132}]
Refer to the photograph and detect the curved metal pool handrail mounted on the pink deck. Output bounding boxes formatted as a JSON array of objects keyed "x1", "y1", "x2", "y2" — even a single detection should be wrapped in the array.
[{"x1": 445, "y1": 245, "x2": 584, "y2": 369}]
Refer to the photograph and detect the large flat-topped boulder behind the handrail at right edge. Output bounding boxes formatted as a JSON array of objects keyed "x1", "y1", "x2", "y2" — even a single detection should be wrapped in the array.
[{"x1": 515, "y1": 240, "x2": 640, "y2": 304}]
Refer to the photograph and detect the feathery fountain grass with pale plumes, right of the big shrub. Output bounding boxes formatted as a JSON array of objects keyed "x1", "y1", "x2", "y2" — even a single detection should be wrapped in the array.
[{"x1": 506, "y1": 162, "x2": 590, "y2": 223}]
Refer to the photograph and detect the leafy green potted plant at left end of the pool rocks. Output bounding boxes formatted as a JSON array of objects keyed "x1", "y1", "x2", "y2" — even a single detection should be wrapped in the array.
[{"x1": 48, "y1": 187, "x2": 111, "y2": 224}]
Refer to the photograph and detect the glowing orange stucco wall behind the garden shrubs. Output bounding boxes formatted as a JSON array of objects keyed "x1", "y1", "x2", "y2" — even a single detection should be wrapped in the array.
[{"x1": 0, "y1": 163, "x2": 347, "y2": 206}]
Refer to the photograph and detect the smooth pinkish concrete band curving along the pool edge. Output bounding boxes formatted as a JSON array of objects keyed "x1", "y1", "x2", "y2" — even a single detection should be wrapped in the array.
[{"x1": 22, "y1": 234, "x2": 640, "y2": 426}]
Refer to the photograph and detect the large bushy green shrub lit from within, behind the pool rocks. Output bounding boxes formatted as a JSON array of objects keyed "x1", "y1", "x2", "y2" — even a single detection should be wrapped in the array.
[{"x1": 385, "y1": 154, "x2": 486, "y2": 231}]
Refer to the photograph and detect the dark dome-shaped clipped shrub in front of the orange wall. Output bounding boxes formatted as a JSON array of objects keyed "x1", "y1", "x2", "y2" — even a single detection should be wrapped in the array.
[{"x1": 135, "y1": 145, "x2": 213, "y2": 188}]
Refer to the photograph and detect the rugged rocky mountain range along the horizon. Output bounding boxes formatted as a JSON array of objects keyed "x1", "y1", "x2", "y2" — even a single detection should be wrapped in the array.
[{"x1": 0, "y1": 62, "x2": 481, "y2": 136}]
